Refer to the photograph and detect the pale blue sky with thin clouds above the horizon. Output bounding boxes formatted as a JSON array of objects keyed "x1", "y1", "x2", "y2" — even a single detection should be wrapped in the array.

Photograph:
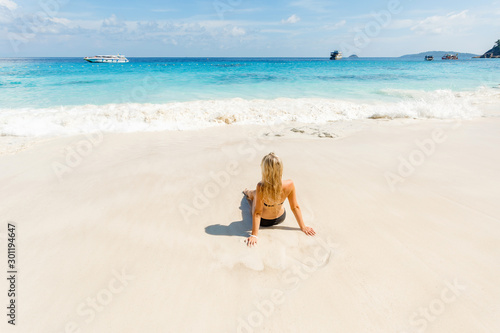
[{"x1": 0, "y1": 0, "x2": 500, "y2": 57}]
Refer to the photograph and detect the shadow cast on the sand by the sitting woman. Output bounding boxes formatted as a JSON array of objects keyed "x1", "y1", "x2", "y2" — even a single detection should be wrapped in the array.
[{"x1": 205, "y1": 196, "x2": 299, "y2": 237}]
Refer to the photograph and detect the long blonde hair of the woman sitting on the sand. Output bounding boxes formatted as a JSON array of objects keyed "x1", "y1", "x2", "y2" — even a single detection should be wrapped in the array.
[{"x1": 260, "y1": 153, "x2": 283, "y2": 209}]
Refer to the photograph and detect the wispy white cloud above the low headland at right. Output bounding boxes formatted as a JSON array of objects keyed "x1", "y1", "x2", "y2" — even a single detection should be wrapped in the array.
[{"x1": 411, "y1": 10, "x2": 475, "y2": 35}]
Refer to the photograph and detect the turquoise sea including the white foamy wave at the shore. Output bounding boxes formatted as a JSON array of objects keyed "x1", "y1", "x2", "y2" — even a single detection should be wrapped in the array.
[{"x1": 0, "y1": 58, "x2": 500, "y2": 136}]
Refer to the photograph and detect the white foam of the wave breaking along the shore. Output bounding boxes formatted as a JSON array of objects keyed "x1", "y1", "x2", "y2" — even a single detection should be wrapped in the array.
[{"x1": 0, "y1": 88, "x2": 500, "y2": 137}]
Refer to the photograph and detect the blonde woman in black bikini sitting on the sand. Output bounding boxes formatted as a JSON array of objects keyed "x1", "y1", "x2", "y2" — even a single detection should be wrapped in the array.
[{"x1": 243, "y1": 153, "x2": 316, "y2": 246}]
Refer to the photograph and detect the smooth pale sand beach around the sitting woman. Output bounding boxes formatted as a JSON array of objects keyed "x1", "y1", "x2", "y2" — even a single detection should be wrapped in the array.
[{"x1": 0, "y1": 117, "x2": 500, "y2": 333}]
